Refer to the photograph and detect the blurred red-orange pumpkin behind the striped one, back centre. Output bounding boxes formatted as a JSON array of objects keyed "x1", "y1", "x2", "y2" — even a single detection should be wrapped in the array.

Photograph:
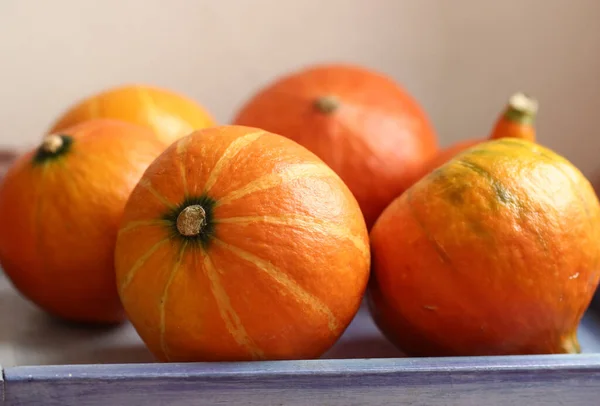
[{"x1": 234, "y1": 65, "x2": 438, "y2": 228}]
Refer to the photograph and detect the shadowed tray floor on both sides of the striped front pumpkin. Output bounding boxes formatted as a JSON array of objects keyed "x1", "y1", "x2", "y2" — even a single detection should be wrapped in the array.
[{"x1": 0, "y1": 272, "x2": 404, "y2": 368}]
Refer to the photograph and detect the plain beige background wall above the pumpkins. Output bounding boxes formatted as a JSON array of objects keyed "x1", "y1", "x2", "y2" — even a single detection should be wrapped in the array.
[{"x1": 0, "y1": 0, "x2": 600, "y2": 174}]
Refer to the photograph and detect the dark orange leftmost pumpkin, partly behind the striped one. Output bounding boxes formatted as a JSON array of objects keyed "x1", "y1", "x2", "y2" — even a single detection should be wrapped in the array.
[{"x1": 0, "y1": 120, "x2": 164, "y2": 323}]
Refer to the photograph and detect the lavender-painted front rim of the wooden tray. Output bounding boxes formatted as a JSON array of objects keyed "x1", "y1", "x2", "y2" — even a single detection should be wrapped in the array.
[{"x1": 5, "y1": 354, "x2": 600, "y2": 406}]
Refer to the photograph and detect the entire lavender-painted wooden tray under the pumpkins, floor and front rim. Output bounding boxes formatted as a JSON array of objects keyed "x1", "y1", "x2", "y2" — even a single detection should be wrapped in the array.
[{"x1": 0, "y1": 268, "x2": 600, "y2": 406}]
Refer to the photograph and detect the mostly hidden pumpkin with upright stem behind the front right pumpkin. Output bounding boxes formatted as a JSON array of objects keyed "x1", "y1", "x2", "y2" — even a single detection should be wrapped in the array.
[{"x1": 414, "y1": 93, "x2": 538, "y2": 181}]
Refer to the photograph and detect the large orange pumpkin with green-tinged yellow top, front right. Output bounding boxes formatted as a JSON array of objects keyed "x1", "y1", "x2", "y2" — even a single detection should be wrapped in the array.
[{"x1": 369, "y1": 138, "x2": 600, "y2": 356}]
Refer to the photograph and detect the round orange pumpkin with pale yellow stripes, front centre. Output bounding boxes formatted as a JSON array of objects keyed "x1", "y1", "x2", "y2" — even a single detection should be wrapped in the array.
[{"x1": 115, "y1": 126, "x2": 370, "y2": 362}]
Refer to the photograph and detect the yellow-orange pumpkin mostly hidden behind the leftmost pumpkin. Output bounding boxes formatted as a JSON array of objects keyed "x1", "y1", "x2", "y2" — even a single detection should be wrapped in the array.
[{"x1": 50, "y1": 85, "x2": 215, "y2": 145}]
